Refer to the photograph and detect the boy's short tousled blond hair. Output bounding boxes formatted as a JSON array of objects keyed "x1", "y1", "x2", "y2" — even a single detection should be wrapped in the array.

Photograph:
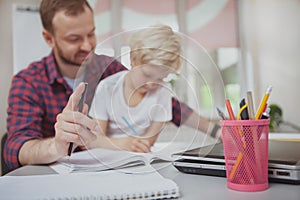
[{"x1": 130, "y1": 25, "x2": 181, "y2": 70}]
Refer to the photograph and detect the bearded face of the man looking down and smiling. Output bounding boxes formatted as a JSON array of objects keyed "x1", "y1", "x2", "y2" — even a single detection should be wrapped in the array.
[{"x1": 52, "y1": 7, "x2": 96, "y2": 67}]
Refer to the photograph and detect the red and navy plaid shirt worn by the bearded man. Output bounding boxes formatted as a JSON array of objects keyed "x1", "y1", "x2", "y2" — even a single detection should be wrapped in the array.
[{"x1": 4, "y1": 52, "x2": 192, "y2": 169}]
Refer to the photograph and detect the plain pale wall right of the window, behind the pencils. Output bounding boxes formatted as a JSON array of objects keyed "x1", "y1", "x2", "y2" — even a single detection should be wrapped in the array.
[{"x1": 239, "y1": 0, "x2": 300, "y2": 126}]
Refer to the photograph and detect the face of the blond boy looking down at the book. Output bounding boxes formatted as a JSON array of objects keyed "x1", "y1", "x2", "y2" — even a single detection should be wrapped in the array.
[{"x1": 131, "y1": 64, "x2": 172, "y2": 93}]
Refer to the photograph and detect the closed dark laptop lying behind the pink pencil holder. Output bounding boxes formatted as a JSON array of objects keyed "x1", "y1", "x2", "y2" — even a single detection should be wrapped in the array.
[{"x1": 173, "y1": 140, "x2": 300, "y2": 184}]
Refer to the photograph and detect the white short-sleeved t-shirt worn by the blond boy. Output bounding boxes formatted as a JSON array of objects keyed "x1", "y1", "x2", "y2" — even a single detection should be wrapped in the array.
[{"x1": 89, "y1": 71, "x2": 172, "y2": 137}]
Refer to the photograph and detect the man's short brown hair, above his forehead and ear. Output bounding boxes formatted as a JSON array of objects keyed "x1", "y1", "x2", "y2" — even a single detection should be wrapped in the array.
[{"x1": 40, "y1": 0, "x2": 93, "y2": 33}]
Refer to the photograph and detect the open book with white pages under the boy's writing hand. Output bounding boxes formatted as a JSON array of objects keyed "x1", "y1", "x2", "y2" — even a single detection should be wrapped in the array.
[{"x1": 50, "y1": 142, "x2": 193, "y2": 174}]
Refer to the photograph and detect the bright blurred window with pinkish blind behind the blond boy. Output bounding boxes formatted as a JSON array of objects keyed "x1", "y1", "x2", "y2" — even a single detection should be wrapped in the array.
[{"x1": 90, "y1": 0, "x2": 240, "y2": 117}]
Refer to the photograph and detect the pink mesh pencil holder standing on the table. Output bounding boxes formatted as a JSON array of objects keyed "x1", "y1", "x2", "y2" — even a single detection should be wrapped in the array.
[{"x1": 221, "y1": 119, "x2": 270, "y2": 192}]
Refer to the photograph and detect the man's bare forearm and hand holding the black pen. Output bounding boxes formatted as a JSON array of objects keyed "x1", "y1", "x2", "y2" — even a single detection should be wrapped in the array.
[{"x1": 6, "y1": 84, "x2": 99, "y2": 168}]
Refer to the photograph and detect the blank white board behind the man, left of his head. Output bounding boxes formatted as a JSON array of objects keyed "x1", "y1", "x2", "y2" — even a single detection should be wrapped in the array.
[{"x1": 12, "y1": 4, "x2": 51, "y2": 74}]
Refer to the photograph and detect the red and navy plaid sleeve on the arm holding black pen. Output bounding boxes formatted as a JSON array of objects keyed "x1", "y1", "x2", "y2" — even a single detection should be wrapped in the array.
[{"x1": 4, "y1": 76, "x2": 47, "y2": 169}]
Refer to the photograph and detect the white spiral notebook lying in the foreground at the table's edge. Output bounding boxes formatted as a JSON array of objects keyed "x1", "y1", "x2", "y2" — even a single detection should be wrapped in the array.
[{"x1": 0, "y1": 166, "x2": 179, "y2": 200}]
